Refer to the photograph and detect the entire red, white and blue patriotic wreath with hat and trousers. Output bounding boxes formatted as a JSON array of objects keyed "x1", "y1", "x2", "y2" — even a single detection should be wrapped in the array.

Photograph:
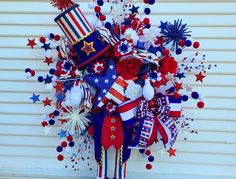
[{"x1": 24, "y1": 0, "x2": 216, "y2": 179}]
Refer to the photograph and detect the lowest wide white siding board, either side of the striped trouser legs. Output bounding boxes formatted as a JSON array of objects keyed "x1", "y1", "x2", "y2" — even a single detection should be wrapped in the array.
[{"x1": 0, "y1": 157, "x2": 235, "y2": 178}]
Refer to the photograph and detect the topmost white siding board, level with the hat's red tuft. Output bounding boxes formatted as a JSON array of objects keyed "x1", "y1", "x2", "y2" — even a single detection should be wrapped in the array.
[{"x1": 0, "y1": 1, "x2": 236, "y2": 14}]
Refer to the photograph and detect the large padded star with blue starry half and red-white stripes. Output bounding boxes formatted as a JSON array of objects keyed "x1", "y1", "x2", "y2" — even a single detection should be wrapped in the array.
[{"x1": 84, "y1": 60, "x2": 128, "y2": 108}]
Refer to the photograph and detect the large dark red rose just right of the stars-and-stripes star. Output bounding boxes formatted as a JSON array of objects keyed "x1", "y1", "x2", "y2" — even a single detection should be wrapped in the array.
[{"x1": 116, "y1": 57, "x2": 142, "y2": 80}]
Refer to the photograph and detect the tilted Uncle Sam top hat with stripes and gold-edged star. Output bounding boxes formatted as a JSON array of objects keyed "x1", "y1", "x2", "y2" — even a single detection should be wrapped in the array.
[{"x1": 54, "y1": 4, "x2": 110, "y2": 67}]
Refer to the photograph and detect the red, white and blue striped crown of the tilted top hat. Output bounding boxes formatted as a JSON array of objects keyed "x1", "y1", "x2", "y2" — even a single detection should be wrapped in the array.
[{"x1": 55, "y1": 4, "x2": 94, "y2": 44}]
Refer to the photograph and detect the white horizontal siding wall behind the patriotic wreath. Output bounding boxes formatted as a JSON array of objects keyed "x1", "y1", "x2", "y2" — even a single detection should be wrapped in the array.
[{"x1": 0, "y1": 0, "x2": 236, "y2": 179}]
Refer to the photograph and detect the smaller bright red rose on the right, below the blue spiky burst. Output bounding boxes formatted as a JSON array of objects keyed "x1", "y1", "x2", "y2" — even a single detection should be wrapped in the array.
[{"x1": 160, "y1": 57, "x2": 178, "y2": 75}]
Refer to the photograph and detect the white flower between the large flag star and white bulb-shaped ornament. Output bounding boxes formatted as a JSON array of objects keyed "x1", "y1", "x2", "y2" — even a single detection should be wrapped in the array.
[{"x1": 125, "y1": 81, "x2": 142, "y2": 100}]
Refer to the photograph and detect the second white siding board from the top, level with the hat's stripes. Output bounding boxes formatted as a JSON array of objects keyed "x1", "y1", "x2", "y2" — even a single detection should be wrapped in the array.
[{"x1": 0, "y1": 14, "x2": 236, "y2": 27}]
